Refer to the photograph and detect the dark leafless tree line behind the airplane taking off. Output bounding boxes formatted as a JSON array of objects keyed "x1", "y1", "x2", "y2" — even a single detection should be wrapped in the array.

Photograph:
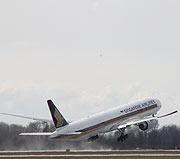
[{"x1": 0, "y1": 122, "x2": 180, "y2": 151}]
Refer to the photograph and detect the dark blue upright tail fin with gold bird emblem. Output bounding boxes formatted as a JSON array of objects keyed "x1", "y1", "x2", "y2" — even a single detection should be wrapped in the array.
[{"x1": 47, "y1": 100, "x2": 68, "y2": 128}]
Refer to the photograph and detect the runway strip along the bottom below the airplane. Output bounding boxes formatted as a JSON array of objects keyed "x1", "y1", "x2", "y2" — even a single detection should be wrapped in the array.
[{"x1": 0, "y1": 150, "x2": 180, "y2": 159}]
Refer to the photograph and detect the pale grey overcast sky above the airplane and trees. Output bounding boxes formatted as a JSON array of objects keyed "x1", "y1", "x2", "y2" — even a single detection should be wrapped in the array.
[{"x1": 0, "y1": 0, "x2": 180, "y2": 125}]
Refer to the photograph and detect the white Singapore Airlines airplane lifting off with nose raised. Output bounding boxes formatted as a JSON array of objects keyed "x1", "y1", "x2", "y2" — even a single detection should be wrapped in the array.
[{"x1": 1, "y1": 98, "x2": 178, "y2": 142}]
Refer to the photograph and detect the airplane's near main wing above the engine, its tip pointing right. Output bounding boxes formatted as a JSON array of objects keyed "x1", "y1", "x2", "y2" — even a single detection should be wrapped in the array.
[{"x1": 118, "y1": 110, "x2": 178, "y2": 129}]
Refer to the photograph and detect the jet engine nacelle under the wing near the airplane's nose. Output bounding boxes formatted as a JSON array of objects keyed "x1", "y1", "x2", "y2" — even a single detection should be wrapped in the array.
[{"x1": 138, "y1": 119, "x2": 158, "y2": 131}]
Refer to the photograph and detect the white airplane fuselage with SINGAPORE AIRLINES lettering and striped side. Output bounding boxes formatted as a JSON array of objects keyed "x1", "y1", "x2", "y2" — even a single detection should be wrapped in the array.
[{"x1": 50, "y1": 98, "x2": 161, "y2": 141}]
